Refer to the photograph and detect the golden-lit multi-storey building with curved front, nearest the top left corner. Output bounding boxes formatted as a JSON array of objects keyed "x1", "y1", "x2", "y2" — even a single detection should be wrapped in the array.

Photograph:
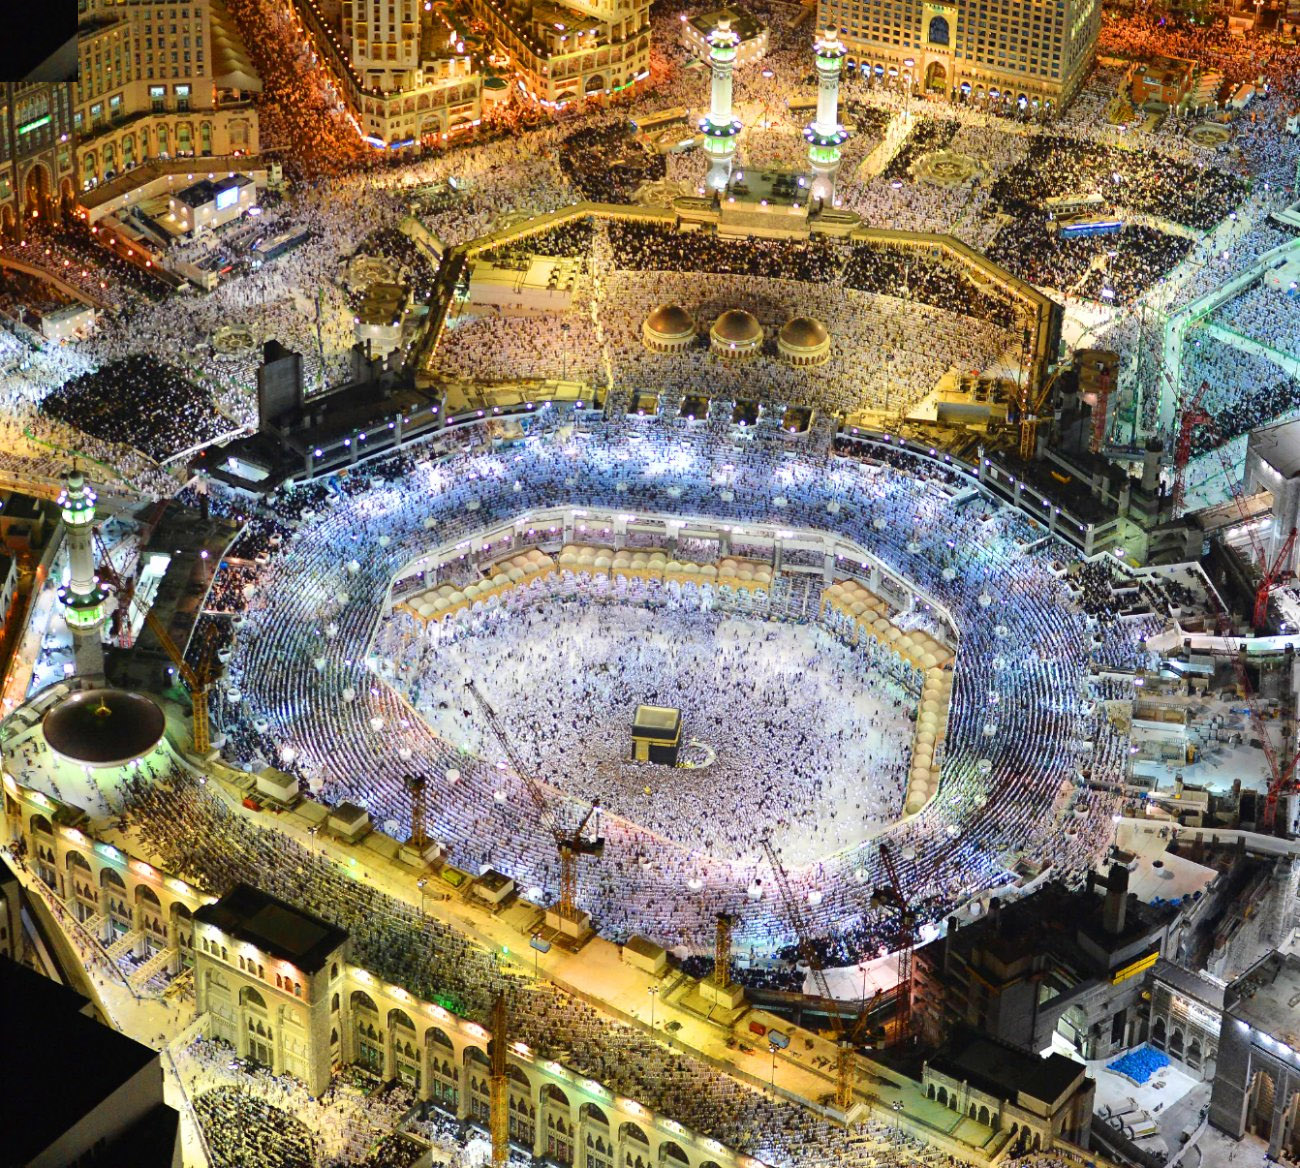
[{"x1": 73, "y1": 0, "x2": 261, "y2": 190}]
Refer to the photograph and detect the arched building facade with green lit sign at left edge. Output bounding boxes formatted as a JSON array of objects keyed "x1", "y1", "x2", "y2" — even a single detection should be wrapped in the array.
[{"x1": 0, "y1": 82, "x2": 77, "y2": 238}]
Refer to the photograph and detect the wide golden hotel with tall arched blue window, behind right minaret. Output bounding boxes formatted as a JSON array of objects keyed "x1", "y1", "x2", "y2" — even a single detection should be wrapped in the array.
[{"x1": 818, "y1": 0, "x2": 1101, "y2": 108}]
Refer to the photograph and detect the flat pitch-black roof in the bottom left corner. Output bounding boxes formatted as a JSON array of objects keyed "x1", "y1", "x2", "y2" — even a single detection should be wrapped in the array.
[{"x1": 0, "y1": 957, "x2": 163, "y2": 1164}]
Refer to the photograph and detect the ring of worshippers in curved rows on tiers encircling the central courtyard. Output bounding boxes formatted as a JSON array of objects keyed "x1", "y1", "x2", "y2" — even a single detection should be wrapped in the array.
[{"x1": 192, "y1": 427, "x2": 1143, "y2": 960}]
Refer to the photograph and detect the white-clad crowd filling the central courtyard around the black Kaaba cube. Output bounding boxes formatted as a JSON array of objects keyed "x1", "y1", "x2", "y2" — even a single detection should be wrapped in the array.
[{"x1": 374, "y1": 580, "x2": 922, "y2": 864}]
